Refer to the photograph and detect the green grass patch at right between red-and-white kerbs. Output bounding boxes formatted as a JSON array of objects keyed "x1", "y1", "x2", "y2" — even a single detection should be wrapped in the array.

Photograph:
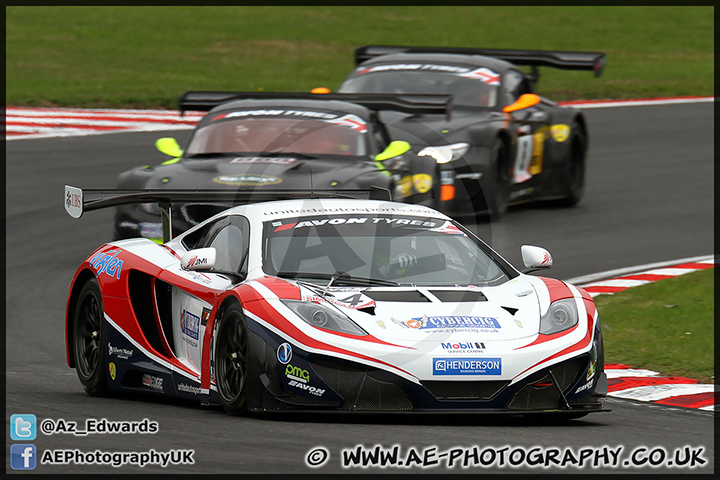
[{"x1": 595, "y1": 268, "x2": 715, "y2": 383}]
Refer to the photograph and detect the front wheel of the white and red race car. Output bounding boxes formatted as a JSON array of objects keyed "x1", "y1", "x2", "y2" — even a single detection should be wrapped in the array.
[{"x1": 215, "y1": 305, "x2": 249, "y2": 415}]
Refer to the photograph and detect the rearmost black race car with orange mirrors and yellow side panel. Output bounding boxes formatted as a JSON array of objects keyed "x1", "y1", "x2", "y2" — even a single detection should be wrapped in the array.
[{"x1": 338, "y1": 46, "x2": 605, "y2": 218}]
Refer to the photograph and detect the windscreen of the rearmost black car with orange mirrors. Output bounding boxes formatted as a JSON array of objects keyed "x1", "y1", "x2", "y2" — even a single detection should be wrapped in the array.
[{"x1": 338, "y1": 64, "x2": 500, "y2": 108}]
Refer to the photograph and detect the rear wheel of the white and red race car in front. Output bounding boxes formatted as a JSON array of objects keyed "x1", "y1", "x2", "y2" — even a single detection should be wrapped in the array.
[{"x1": 72, "y1": 278, "x2": 108, "y2": 396}]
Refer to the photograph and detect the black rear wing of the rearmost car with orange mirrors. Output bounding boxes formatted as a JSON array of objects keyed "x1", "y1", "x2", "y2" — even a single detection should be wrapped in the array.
[{"x1": 355, "y1": 45, "x2": 605, "y2": 77}]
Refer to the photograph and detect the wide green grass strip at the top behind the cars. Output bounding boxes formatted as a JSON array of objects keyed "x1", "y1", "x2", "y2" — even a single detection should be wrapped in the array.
[{"x1": 5, "y1": 6, "x2": 714, "y2": 108}]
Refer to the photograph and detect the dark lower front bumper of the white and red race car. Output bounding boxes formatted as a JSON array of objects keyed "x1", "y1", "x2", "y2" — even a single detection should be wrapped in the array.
[{"x1": 240, "y1": 325, "x2": 607, "y2": 414}]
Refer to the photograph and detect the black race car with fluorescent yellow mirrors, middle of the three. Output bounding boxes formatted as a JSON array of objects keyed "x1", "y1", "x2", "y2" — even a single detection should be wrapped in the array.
[{"x1": 114, "y1": 92, "x2": 451, "y2": 242}]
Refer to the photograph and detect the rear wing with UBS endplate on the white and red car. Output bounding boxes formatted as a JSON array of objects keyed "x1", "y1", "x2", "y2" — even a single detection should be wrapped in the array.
[{"x1": 64, "y1": 185, "x2": 391, "y2": 242}]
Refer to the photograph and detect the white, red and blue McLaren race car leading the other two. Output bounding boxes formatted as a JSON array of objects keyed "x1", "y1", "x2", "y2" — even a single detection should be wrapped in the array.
[{"x1": 65, "y1": 186, "x2": 607, "y2": 418}]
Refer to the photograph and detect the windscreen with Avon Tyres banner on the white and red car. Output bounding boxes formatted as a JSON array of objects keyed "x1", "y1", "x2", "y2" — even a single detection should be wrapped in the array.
[{"x1": 263, "y1": 214, "x2": 517, "y2": 286}]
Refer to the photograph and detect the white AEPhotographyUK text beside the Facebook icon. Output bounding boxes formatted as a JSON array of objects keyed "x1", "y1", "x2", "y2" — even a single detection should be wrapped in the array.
[{"x1": 40, "y1": 449, "x2": 195, "y2": 467}]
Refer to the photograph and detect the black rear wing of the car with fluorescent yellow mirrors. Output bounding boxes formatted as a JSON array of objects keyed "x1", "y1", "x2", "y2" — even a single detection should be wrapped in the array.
[{"x1": 180, "y1": 91, "x2": 452, "y2": 115}]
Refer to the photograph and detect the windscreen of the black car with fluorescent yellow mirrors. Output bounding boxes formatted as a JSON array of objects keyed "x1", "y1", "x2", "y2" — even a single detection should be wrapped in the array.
[{"x1": 187, "y1": 109, "x2": 367, "y2": 156}]
